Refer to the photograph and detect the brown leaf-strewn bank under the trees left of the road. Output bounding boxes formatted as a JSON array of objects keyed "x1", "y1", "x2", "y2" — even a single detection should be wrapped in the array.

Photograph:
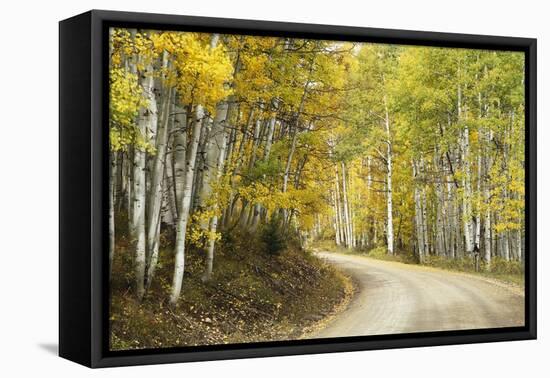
[{"x1": 110, "y1": 230, "x2": 353, "y2": 350}]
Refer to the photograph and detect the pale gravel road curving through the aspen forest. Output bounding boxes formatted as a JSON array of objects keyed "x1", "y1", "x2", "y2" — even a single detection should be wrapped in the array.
[{"x1": 314, "y1": 252, "x2": 525, "y2": 337}]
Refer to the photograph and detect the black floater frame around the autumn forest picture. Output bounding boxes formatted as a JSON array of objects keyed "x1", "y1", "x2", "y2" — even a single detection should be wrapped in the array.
[{"x1": 59, "y1": 10, "x2": 537, "y2": 368}]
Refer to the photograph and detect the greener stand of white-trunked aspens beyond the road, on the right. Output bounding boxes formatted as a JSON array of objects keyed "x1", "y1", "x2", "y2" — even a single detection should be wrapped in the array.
[{"x1": 327, "y1": 45, "x2": 525, "y2": 268}]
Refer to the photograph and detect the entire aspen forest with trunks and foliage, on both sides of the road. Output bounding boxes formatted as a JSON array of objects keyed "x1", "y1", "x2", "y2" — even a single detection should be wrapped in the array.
[{"x1": 110, "y1": 29, "x2": 524, "y2": 304}]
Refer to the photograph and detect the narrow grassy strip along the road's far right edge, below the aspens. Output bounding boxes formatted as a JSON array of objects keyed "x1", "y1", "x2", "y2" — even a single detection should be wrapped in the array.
[{"x1": 313, "y1": 240, "x2": 525, "y2": 287}]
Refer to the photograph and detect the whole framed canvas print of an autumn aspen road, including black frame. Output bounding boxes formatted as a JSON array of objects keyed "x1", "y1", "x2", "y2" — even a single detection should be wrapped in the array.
[{"x1": 59, "y1": 11, "x2": 536, "y2": 367}]
